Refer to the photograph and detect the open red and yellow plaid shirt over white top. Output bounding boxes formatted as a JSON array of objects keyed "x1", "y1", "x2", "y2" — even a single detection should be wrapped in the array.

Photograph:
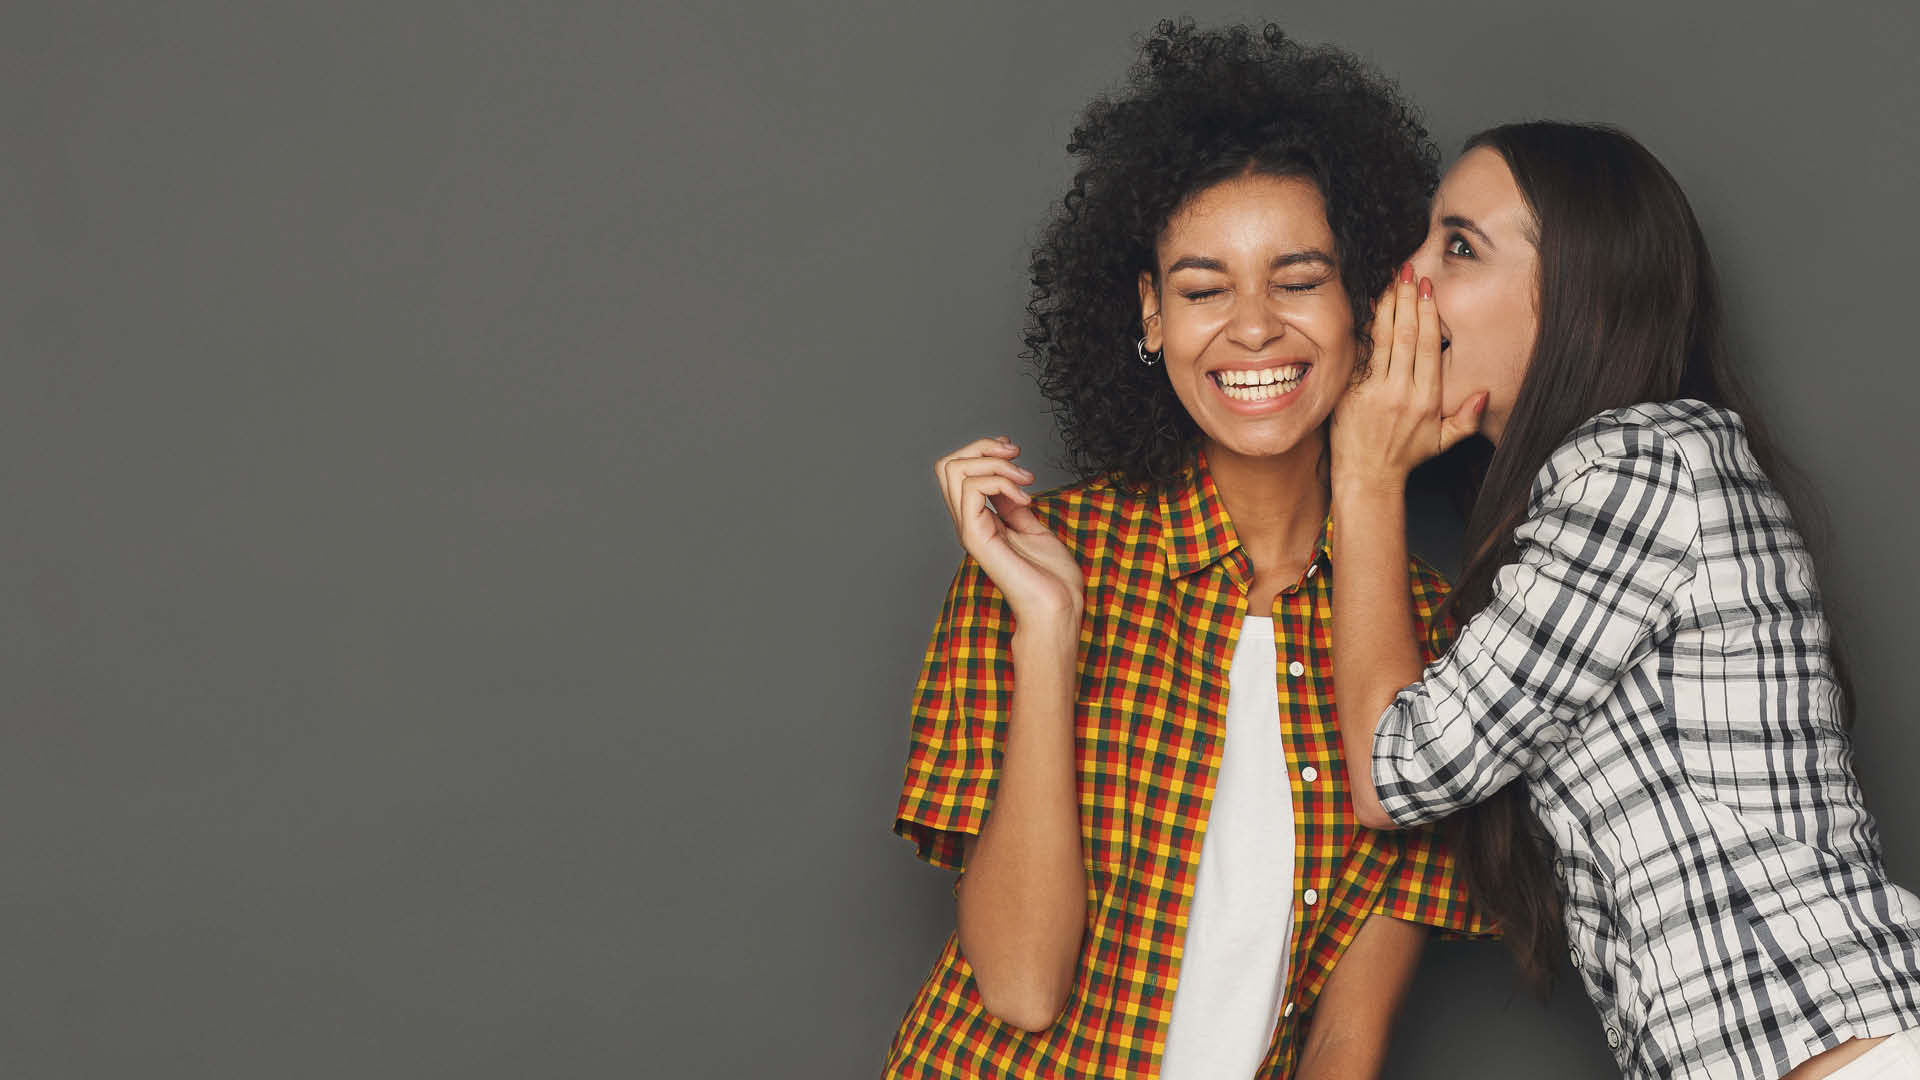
[{"x1": 887, "y1": 447, "x2": 1484, "y2": 1078}]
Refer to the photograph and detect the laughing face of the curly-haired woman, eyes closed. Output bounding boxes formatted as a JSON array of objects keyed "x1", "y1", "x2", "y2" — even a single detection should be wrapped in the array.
[{"x1": 1140, "y1": 175, "x2": 1357, "y2": 457}]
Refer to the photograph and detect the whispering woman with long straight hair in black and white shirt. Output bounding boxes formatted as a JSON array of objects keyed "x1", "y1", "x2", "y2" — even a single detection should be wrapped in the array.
[{"x1": 1332, "y1": 123, "x2": 1920, "y2": 1080}]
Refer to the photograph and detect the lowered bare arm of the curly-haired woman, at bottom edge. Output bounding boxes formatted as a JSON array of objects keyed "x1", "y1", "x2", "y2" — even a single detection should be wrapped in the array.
[{"x1": 1294, "y1": 915, "x2": 1427, "y2": 1080}]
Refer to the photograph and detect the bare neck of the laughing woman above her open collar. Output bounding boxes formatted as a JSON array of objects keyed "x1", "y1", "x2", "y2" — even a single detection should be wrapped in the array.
[{"x1": 1206, "y1": 429, "x2": 1331, "y2": 575}]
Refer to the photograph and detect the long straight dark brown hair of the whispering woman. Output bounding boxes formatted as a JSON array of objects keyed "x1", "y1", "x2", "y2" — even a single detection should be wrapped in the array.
[{"x1": 1448, "y1": 121, "x2": 1851, "y2": 994}]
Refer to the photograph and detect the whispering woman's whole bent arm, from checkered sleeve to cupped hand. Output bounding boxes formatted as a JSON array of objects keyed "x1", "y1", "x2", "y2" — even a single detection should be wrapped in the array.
[{"x1": 1332, "y1": 275, "x2": 1699, "y2": 824}]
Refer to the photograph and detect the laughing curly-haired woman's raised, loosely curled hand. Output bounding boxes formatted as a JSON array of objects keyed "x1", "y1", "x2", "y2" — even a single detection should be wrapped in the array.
[{"x1": 933, "y1": 436, "x2": 1087, "y2": 634}]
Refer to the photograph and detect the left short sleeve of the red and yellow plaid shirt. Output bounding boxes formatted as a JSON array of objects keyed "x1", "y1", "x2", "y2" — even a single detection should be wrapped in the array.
[{"x1": 893, "y1": 555, "x2": 1014, "y2": 871}]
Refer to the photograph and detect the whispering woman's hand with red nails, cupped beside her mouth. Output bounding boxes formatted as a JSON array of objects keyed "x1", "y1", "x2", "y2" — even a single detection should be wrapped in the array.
[{"x1": 1332, "y1": 263, "x2": 1486, "y2": 486}]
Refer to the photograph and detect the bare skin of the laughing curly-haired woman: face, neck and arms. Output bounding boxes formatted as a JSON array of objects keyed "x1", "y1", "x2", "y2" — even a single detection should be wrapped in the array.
[{"x1": 935, "y1": 175, "x2": 1427, "y2": 1080}]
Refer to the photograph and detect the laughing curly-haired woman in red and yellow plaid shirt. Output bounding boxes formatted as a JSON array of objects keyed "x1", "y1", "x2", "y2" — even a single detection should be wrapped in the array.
[{"x1": 887, "y1": 23, "x2": 1480, "y2": 1080}]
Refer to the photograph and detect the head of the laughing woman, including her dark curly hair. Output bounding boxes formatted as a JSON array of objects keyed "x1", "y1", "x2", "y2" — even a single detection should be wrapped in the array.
[{"x1": 1025, "y1": 23, "x2": 1436, "y2": 486}]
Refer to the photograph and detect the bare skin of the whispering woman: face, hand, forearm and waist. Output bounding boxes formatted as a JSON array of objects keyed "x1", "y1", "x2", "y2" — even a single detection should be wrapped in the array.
[{"x1": 1332, "y1": 148, "x2": 1882, "y2": 1080}]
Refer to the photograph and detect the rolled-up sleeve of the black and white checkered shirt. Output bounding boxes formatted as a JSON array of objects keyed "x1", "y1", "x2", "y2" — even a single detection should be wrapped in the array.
[{"x1": 1373, "y1": 425, "x2": 1699, "y2": 824}]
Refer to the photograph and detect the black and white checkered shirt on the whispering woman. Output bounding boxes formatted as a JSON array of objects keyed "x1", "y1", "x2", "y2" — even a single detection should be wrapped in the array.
[{"x1": 1373, "y1": 402, "x2": 1920, "y2": 1080}]
